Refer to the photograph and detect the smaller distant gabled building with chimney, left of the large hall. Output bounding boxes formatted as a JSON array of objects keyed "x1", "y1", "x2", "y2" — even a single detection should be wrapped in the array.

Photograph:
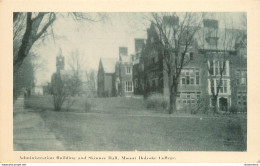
[{"x1": 97, "y1": 47, "x2": 134, "y2": 97}]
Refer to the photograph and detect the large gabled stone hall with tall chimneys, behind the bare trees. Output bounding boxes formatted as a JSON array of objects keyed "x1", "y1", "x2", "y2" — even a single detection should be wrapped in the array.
[{"x1": 133, "y1": 19, "x2": 247, "y2": 111}]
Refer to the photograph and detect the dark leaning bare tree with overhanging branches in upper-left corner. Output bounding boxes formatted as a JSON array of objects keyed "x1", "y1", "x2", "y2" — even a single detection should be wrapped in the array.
[{"x1": 13, "y1": 12, "x2": 106, "y2": 73}]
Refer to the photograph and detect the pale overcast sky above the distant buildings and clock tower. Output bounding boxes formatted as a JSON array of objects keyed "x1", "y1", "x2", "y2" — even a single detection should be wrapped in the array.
[{"x1": 34, "y1": 13, "x2": 244, "y2": 84}]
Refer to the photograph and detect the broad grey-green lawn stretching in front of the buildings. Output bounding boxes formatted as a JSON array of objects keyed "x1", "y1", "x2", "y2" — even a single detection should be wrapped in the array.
[{"x1": 19, "y1": 94, "x2": 247, "y2": 151}]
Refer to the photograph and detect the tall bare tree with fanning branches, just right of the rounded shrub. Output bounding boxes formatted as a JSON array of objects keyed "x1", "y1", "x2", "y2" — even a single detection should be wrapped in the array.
[{"x1": 152, "y1": 13, "x2": 203, "y2": 114}]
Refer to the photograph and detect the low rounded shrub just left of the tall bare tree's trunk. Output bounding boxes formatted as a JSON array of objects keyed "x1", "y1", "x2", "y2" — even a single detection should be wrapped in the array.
[{"x1": 146, "y1": 93, "x2": 169, "y2": 110}]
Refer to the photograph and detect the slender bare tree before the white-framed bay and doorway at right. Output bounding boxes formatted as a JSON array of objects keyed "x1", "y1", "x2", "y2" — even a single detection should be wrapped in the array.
[{"x1": 198, "y1": 16, "x2": 240, "y2": 113}]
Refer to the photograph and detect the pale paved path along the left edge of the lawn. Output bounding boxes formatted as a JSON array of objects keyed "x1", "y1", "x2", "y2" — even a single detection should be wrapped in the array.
[{"x1": 13, "y1": 97, "x2": 64, "y2": 151}]
